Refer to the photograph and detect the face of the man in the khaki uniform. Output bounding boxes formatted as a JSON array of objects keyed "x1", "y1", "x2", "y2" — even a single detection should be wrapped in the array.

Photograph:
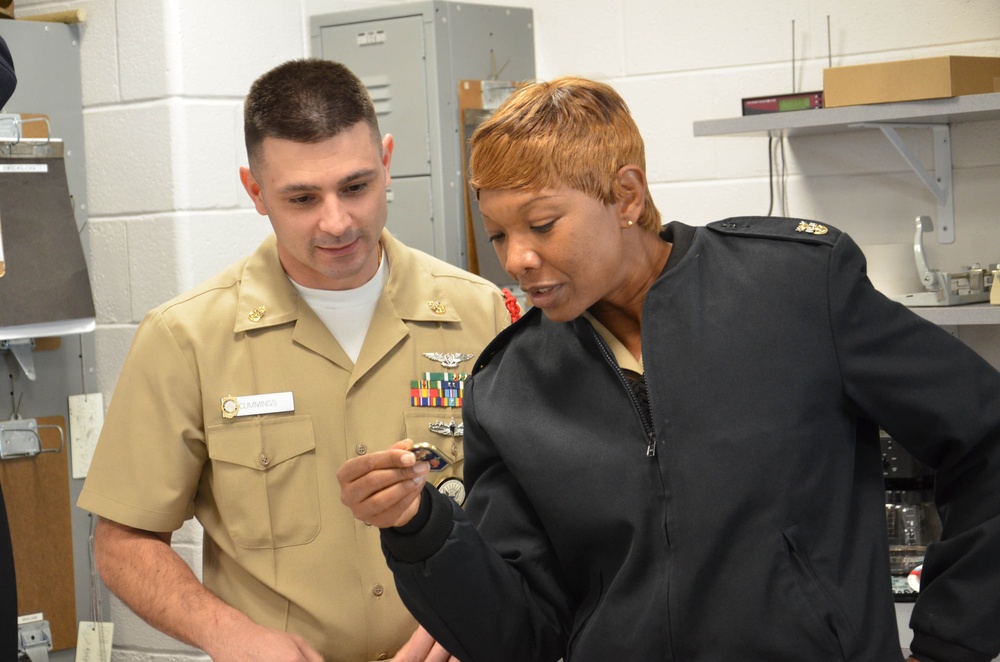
[{"x1": 240, "y1": 122, "x2": 393, "y2": 290}]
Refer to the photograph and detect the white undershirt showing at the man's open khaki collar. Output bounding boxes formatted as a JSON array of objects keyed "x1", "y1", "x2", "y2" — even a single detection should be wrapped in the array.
[{"x1": 292, "y1": 252, "x2": 389, "y2": 363}]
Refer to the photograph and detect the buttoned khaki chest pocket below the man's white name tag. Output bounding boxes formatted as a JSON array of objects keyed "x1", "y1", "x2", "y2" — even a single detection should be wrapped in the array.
[{"x1": 206, "y1": 416, "x2": 320, "y2": 549}]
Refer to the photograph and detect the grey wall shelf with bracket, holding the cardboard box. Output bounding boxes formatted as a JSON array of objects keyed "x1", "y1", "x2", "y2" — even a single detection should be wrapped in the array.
[{"x1": 694, "y1": 93, "x2": 1000, "y2": 244}]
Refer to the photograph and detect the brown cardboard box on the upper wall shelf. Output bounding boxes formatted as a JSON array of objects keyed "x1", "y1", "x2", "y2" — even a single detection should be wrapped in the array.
[{"x1": 823, "y1": 55, "x2": 1000, "y2": 108}]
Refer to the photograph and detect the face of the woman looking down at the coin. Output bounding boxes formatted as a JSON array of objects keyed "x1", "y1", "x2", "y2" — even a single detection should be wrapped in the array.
[{"x1": 479, "y1": 186, "x2": 628, "y2": 322}]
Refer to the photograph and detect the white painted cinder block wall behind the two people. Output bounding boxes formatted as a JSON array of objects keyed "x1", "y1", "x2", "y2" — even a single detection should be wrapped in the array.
[{"x1": 17, "y1": 0, "x2": 1000, "y2": 662}]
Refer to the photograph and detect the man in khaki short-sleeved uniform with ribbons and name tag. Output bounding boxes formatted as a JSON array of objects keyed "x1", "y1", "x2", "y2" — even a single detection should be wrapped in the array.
[{"x1": 79, "y1": 60, "x2": 510, "y2": 662}]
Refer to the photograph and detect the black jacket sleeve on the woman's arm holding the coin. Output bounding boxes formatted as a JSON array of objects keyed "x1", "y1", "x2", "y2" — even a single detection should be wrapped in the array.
[{"x1": 382, "y1": 379, "x2": 569, "y2": 662}]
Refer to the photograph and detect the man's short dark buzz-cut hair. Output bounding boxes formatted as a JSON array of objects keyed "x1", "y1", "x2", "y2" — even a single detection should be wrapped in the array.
[{"x1": 243, "y1": 58, "x2": 381, "y2": 168}]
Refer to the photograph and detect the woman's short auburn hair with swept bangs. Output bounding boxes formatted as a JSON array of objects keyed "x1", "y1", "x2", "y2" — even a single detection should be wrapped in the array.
[{"x1": 469, "y1": 76, "x2": 661, "y2": 232}]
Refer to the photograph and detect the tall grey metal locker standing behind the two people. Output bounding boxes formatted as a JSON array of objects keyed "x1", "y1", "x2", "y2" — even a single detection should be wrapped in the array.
[{"x1": 310, "y1": 0, "x2": 535, "y2": 268}]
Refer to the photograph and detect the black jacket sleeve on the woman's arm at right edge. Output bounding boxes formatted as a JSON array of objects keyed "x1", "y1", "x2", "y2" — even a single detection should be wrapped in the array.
[{"x1": 829, "y1": 236, "x2": 1000, "y2": 662}]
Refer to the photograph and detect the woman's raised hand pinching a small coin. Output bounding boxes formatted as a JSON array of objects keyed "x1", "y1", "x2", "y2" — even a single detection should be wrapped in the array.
[{"x1": 337, "y1": 439, "x2": 430, "y2": 529}]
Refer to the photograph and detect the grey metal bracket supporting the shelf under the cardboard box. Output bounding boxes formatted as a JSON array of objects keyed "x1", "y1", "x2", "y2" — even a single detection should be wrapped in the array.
[{"x1": 850, "y1": 122, "x2": 955, "y2": 244}]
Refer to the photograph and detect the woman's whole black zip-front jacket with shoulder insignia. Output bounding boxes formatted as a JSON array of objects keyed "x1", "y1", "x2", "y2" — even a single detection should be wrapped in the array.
[{"x1": 383, "y1": 218, "x2": 1000, "y2": 662}]
